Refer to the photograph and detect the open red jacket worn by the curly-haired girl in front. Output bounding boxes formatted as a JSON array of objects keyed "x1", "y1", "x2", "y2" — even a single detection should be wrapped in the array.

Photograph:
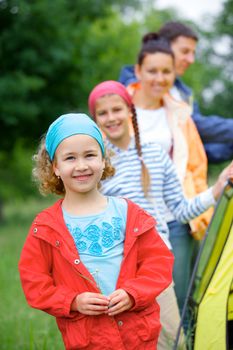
[{"x1": 19, "y1": 200, "x2": 173, "y2": 350}]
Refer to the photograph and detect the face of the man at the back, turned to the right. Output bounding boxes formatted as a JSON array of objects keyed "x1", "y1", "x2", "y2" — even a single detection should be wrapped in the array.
[{"x1": 171, "y1": 36, "x2": 197, "y2": 76}]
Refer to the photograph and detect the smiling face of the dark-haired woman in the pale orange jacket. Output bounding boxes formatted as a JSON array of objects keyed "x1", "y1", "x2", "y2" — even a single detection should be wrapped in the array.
[{"x1": 135, "y1": 52, "x2": 175, "y2": 100}]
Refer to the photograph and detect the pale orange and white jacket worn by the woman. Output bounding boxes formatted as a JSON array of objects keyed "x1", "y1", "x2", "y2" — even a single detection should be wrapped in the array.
[{"x1": 127, "y1": 83, "x2": 213, "y2": 239}]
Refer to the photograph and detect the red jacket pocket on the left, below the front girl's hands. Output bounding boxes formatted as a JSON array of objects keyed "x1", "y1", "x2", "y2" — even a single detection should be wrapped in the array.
[{"x1": 58, "y1": 314, "x2": 93, "y2": 350}]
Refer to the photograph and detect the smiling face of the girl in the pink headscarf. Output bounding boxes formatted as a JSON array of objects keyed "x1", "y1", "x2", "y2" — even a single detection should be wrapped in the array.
[{"x1": 95, "y1": 94, "x2": 131, "y2": 144}]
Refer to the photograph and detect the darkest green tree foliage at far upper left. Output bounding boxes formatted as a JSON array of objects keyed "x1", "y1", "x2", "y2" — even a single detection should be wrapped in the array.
[{"x1": 0, "y1": 0, "x2": 78, "y2": 150}]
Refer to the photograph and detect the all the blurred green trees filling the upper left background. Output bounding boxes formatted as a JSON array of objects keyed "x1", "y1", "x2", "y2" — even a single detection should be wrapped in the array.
[{"x1": 0, "y1": 0, "x2": 149, "y2": 150}]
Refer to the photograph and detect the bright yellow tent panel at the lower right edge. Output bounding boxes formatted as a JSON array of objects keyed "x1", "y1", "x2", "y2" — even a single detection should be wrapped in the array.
[{"x1": 194, "y1": 225, "x2": 233, "y2": 350}]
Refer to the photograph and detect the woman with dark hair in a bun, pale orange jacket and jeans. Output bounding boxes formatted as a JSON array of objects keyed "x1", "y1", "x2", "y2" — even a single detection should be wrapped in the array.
[{"x1": 128, "y1": 33, "x2": 213, "y2": 318}]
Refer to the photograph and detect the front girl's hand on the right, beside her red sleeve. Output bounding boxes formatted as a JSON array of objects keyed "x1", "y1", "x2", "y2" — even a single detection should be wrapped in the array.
[{"x1": 106, "y1": 289, "x2": 134, "y2": 316}]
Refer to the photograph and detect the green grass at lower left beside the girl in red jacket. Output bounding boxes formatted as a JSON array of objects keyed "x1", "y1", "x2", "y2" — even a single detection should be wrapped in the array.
[{"x1": 0, "y1": 199, "x2": 64, "y2": 350}]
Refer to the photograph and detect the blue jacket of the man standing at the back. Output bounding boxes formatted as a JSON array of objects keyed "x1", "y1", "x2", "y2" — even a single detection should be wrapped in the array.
[{"x1": 119, "y1": 65, "x2": 233, "y2": 163}]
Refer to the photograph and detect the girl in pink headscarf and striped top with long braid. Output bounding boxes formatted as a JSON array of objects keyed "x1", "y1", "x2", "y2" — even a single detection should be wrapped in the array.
[{"x1": 89, "y1": 81, "x2": 233, "y2": 350}]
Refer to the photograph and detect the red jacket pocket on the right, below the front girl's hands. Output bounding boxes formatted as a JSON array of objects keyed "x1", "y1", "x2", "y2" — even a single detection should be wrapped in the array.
[{"x1": 137, "y1": 304, "x2": 161, "y2": 341}]
